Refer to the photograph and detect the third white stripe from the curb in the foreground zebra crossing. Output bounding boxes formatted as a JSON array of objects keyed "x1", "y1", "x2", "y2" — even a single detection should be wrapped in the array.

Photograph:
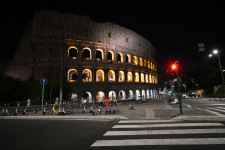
[{"x1": 103, "y1": 128, "x2": 225, "y2": 136}]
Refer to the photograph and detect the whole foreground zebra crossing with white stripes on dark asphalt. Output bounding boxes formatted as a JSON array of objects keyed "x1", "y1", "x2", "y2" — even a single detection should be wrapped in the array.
[{"x1": 91, "y1": 120, "x2": 225, "y2": 147}]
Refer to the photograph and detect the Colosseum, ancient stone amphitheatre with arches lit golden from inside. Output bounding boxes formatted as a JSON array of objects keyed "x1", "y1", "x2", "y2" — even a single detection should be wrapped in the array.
[{"x1": 6, "y1": 11, "x2": 158, "y2": 102}]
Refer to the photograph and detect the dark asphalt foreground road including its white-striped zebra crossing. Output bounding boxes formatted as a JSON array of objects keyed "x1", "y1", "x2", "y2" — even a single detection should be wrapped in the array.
[{"x1": 0, "y1": 119, "x2": 225, "y2": 150}]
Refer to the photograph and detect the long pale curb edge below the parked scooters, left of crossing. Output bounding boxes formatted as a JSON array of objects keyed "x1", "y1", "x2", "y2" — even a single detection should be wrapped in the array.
[{"x1": 0, "y1": 116, "x2": 128, "y2": 120}]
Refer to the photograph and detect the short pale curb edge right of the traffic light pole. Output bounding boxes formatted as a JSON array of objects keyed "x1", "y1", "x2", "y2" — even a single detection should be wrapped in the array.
[{"x1": 171, "y1": 116, "x2": 225, "y2": 121}]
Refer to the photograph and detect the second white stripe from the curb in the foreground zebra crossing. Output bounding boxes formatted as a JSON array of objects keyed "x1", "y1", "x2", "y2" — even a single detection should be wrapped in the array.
[{"x1": 112, "y1": 123, "x2": 224, "y2": 128}]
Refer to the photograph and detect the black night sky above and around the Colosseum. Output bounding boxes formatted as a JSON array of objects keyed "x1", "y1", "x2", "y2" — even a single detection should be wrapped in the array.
[{"x1": 0, "y1": 0, "x2": 225, "y2": 87}]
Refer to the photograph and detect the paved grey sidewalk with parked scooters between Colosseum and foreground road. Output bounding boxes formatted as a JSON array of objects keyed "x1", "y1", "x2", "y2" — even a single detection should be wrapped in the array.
[{"x1": 0, "y1": 99, "x2": 225, "y2": 121}]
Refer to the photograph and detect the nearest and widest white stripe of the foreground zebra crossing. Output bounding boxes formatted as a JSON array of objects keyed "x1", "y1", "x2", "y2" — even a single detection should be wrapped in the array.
[{"x1": 91, "y1": 138, "x2": 225, "y2": 147}]
